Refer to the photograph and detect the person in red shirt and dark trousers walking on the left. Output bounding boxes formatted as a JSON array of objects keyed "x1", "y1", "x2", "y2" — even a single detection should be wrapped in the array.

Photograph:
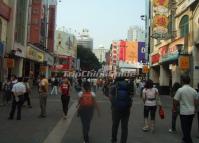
[{"x1": 59, "y1": 79, "x2": 70, "y2": 119}]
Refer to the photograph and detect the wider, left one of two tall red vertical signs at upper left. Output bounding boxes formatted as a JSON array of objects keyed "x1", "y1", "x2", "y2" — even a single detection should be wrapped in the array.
[{"x1": 29, "y1": 0, "x2": 43, "y2": 44}]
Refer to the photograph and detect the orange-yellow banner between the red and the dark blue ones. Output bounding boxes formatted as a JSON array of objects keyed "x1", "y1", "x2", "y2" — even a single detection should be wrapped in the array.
[{"x1": 126, "y1": 41, "x2": 138, "y2": 63}]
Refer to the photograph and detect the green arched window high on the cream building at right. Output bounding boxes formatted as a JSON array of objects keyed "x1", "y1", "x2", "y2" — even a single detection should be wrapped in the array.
[{"x1": 179, "y1": 15, "x2": 189, "y2": 37}]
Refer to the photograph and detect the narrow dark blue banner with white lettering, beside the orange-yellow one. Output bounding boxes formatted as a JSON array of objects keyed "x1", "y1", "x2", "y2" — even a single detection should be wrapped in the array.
[{"x1": 138, "y1": 42, "x2": 146, "y2": 63}]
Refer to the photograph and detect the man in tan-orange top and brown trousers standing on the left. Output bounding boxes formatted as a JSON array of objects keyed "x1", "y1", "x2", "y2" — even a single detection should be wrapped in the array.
[{"x1": 39, "y1": 75, "x2": 48, "y2": 118}]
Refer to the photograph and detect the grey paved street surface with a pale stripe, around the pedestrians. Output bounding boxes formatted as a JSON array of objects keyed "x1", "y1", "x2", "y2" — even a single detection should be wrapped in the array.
[{"x1": 0, "y1": 87, "x2": 199, "y2": 143}]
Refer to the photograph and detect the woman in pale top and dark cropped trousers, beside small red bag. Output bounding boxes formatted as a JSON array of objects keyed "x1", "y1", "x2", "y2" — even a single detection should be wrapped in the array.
[{"x1": 142, "y1": 79, "x2": 161, "y2": 132}]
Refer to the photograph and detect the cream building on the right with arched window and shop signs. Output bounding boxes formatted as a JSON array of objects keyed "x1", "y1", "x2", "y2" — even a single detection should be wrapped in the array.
[{"x1": 150, "y1": 0, "x2": 199, "y2": 94}]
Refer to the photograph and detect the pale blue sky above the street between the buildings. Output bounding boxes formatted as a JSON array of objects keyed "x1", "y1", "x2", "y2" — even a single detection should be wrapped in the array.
[{"x1": 56, "y1": 0, "x2": 145, "y2": 49}]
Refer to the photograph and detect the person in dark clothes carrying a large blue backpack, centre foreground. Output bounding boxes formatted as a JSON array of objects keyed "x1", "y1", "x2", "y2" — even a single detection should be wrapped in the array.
[{"x1": 109, "y1": 77, "x2": 134, "y2": 143}]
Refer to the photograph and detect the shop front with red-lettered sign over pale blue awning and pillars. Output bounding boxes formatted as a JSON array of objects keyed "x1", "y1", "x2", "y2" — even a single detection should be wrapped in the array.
[{"x1": 160, "y1": 38, "x2": 184, "y2": 94}]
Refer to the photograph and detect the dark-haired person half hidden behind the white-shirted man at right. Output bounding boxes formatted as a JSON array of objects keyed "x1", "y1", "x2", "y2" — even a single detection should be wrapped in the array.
[{"x1": 169, "y1": 82, "x2": 181, "y2": 133}]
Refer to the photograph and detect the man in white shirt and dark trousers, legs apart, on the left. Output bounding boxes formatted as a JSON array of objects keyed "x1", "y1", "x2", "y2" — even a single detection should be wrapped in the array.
[{"x1": 8, "y1": 77, "x2": 26, "y2": 120}]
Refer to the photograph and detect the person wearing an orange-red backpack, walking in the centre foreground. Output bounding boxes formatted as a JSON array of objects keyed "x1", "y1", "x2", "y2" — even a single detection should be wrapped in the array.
[{"x1": 78, "y1": 82, "x2": 100, "y2": 143}]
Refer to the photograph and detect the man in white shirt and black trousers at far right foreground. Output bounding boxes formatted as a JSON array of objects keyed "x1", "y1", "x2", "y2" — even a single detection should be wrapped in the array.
[{"x1": 174, "y1": 74, "x2": 197, "y2": 143}]
